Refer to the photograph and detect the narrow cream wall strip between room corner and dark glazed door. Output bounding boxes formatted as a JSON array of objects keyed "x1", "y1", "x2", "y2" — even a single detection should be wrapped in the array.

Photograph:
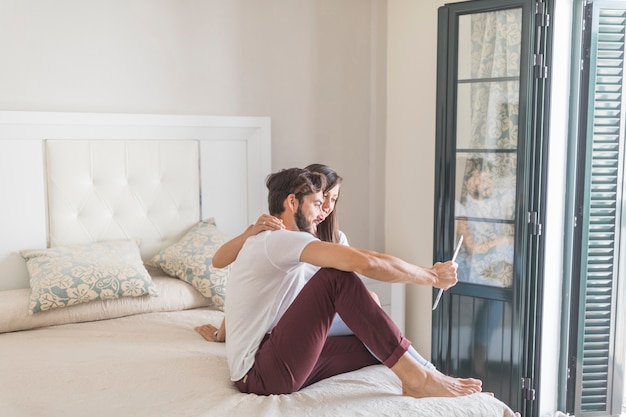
[{"x1": 385, "y1": 0, "x2": 436, "y2": 357}]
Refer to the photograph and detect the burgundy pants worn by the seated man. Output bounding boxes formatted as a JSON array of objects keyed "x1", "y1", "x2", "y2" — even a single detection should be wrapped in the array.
[{"x1": 235, "y1": 268, "x2": 411, "y2": 395}]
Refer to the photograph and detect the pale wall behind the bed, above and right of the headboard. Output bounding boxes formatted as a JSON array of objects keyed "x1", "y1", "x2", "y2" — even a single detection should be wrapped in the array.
[{"x1": 0, "y1": 0, "x2": 386, "y2": 254}]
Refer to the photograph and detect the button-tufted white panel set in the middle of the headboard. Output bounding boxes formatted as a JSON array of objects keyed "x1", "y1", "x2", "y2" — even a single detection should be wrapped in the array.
[{"x1": 45, "y1": 140, "x2": 200, "y2": 259}]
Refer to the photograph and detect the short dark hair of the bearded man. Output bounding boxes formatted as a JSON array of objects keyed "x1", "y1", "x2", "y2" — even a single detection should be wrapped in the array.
[{"x1": 265, "y1": 168, "x2": 326, "y2": 216}]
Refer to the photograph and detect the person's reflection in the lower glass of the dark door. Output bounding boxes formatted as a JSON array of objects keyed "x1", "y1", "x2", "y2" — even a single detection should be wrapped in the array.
[{"x1": 455, "y1": 158, "x2": 514, "y2": 287}]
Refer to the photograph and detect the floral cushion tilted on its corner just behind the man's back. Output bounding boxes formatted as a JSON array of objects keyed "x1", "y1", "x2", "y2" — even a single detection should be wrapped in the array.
[{"x1": 147, "y1": 218, "x2": 230, "y2": 310}]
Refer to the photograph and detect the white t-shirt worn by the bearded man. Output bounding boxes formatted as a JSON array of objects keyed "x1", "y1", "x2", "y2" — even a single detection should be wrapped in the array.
[{"x1": 224, "y1": 230, "x2": 318, "y2": 381}]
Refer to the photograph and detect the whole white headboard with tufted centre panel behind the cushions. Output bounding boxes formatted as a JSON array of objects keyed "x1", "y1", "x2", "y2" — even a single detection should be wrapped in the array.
[{"x1": 0, "y1": 112, "x2": 271, "y2": 290}]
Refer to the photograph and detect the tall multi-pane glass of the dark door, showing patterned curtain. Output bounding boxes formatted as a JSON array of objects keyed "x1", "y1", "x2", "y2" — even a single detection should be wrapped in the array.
[{"x1": 455, "y1": 9, "x2": 522, "y2": 287}]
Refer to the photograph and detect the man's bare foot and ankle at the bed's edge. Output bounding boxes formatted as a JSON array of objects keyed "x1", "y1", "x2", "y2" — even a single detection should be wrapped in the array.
[{"x1": 391, "y1": 353, "x2": 482, "y2": 398}]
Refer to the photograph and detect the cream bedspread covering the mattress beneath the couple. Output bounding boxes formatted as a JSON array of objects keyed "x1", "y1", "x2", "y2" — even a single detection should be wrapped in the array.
[{"x1": 0, "y1": 308, "x2": 513, "y2": 417}]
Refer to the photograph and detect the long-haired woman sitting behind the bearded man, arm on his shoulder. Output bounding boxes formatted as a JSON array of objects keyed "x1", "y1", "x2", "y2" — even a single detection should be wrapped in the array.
[{"x1": 195, "y1": 164, "x2": 435, "y2": 369}]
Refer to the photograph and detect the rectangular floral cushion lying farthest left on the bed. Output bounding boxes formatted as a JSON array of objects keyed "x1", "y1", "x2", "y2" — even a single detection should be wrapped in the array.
[{"x1": 20, "y1": 240, "x2": 157, "y2": 314}]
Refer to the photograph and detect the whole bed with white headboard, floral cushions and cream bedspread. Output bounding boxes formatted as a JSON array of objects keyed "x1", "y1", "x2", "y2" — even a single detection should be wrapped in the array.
[{"x1": 0, "y1": 112, "x2": 513, "y2": 417}]
